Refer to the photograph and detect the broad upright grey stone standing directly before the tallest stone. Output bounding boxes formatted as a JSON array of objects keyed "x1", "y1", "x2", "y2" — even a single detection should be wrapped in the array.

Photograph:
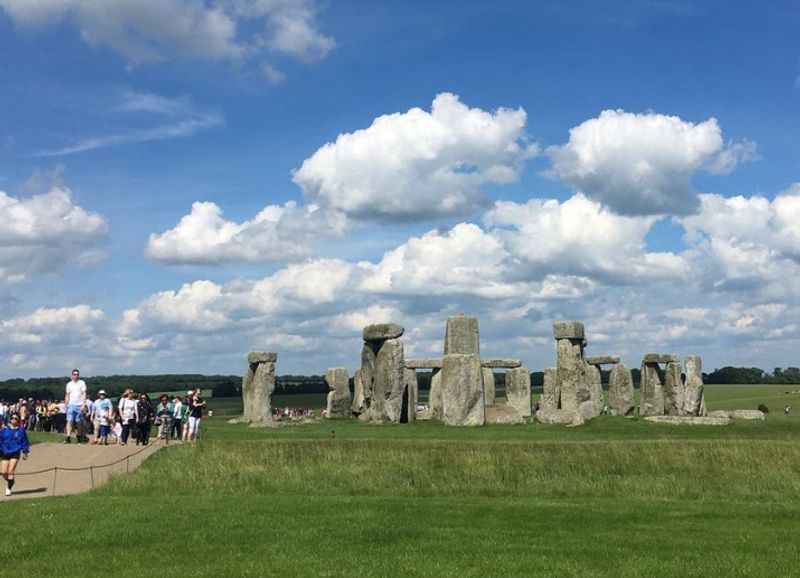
[{"x1": 442, "y1": 348, "x2": 486, "y2": 426}]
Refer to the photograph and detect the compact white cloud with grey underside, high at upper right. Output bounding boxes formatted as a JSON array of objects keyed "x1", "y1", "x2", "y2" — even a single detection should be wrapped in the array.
[{"x1": 547, "y1": 110, "x2": 756, "y2": 215}]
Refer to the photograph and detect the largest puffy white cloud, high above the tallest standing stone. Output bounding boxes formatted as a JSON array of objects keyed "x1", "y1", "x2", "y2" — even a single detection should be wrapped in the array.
[{"x1": 294, "y1": 93, "x2": 537, "y2": 220}]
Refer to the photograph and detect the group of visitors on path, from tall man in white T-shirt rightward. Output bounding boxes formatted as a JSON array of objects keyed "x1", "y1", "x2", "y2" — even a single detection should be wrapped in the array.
[{"x1": 64, "y1": 369, "x2": 207, "y2": 446}]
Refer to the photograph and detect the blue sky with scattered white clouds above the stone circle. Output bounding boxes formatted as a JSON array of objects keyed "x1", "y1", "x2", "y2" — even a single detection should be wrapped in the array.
[{"x1": 0, "y1": 0, "x2": 800, "y2": 377}]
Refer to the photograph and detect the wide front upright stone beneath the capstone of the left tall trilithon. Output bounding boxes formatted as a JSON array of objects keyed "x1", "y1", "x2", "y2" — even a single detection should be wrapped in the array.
[{"x1": 369, "y1": 339, "x2": 405, "y2": 423}]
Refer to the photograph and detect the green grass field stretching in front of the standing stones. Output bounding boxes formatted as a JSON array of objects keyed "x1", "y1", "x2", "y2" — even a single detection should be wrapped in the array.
[{"x1": 6, "y1": 385, "x2": 800, "y2": 578}]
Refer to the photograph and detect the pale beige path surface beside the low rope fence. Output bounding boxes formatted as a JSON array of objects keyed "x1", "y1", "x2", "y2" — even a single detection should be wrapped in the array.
[{"x1": 0, "y1": 440, "x2": 166, "y2": 502}]
